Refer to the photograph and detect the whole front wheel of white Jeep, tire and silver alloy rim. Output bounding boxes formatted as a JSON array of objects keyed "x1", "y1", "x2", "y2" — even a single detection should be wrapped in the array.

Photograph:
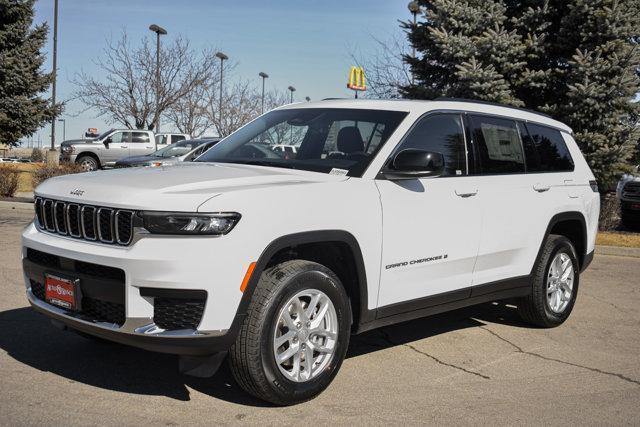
[{"x1": 229, "y1": 260, "x2": 351, "y2": 405}]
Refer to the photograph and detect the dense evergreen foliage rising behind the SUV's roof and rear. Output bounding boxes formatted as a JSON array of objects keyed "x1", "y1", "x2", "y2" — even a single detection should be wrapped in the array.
[{"x1": 402, "y1": 0, "x2": 640, "y2": 186}]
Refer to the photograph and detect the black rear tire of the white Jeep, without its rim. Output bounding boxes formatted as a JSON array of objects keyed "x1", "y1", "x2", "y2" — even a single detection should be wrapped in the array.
[{"x1": 517, "y1": 234, "x2": 580, "y2": 328}]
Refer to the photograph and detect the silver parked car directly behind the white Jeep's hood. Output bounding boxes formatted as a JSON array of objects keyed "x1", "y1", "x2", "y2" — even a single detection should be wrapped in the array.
[{"x1": 115, "y1": 138, "x2": 220, "y2": 168}]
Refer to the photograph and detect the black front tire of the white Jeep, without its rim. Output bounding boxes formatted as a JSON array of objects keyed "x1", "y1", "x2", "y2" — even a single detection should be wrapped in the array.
[{"x1": 229, "y1": 260, "x2": 351, "y2": 405}]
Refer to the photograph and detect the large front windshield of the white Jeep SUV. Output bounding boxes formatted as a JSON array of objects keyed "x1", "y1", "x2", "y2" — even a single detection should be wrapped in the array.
[{"x1": 196, "y1": 108, "x2": 407, "y2": 176}]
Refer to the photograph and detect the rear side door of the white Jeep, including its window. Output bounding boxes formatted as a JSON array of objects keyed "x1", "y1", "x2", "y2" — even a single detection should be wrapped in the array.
[{"x1": 468, "y1": 114, "x2": 557, "y2": 293}]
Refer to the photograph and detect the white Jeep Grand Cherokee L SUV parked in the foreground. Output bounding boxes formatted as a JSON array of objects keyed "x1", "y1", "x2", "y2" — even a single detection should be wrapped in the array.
[{"x1": 22, "y1": 100, "x2": 600, "y2": 404}]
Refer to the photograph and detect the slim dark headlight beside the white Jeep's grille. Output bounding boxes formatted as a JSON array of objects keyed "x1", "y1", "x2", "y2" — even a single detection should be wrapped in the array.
[{"x1": 141, "y1": 212, "x2": 240, "y2": 236}]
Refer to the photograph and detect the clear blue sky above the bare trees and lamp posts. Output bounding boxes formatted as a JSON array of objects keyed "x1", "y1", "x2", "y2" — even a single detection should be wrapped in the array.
[{"x1": 27, "y1": 0, "x2": 409, "y2": 144}]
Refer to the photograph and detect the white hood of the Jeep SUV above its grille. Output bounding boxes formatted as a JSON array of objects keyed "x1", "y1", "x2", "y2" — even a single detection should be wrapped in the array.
[{"x1": 35, "y1": 162, "x2": 348, "y2": 212}]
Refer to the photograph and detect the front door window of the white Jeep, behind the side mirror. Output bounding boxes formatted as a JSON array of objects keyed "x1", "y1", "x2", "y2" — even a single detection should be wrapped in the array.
[{"x1": 396, "y1": 114, "x2": 467, "y2": 176}]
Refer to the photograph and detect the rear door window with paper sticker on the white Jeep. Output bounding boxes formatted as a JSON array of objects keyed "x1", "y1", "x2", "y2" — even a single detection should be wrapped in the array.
[{"x1": 471, "y1": 116, "x2": 525, "y2": 174}]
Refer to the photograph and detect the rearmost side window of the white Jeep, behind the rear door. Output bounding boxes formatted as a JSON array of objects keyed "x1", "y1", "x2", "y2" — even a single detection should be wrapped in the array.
[{"x1": 523, "y1": 123, "x2": 574, "y2": 172}]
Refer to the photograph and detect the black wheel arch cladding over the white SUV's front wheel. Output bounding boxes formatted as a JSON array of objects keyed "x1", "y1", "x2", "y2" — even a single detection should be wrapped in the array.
[{"x1": 237, "y1": 230, "x2": 371, "y2": 325}]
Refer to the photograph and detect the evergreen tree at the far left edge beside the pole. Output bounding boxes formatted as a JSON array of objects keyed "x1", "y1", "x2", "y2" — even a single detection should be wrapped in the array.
[{"x1": 0, "y1": 0, "x2": 59, "y2": 146}]
